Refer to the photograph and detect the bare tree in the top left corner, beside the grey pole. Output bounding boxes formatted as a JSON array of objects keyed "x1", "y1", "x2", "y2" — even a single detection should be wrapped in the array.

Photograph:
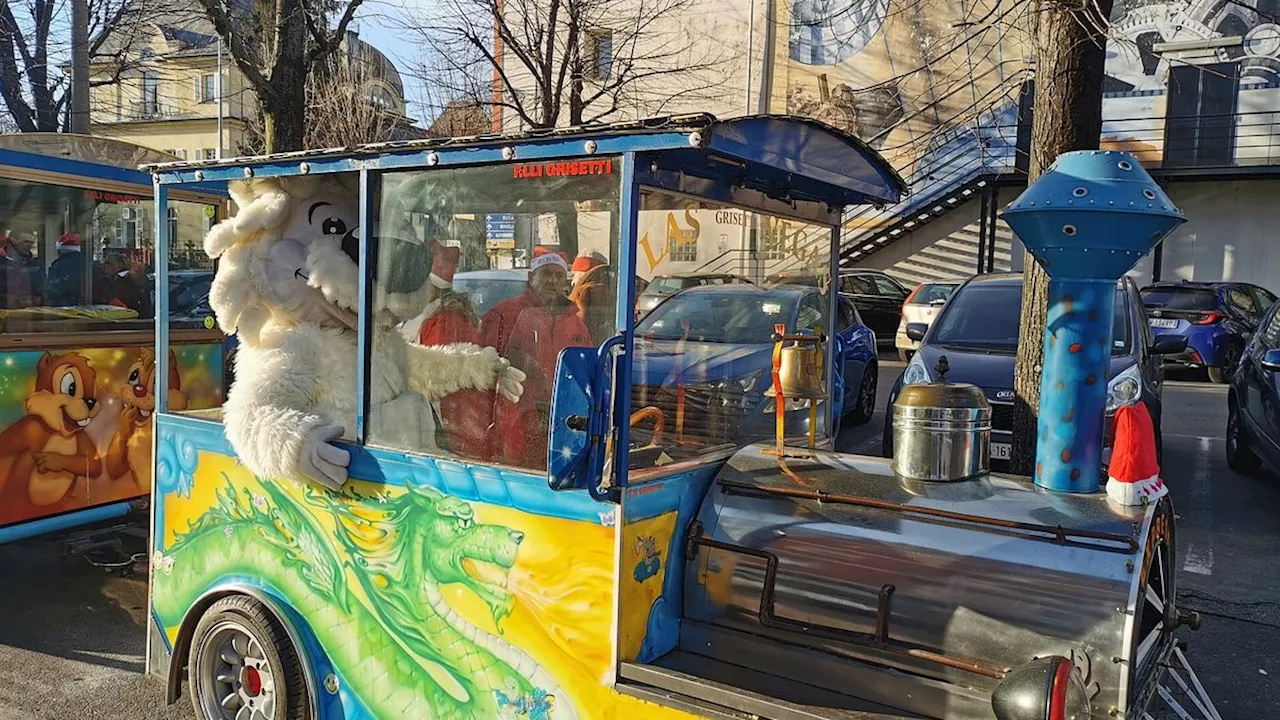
[{"x1": 0, "y1": 0, "x2": 156, "y2": 132}]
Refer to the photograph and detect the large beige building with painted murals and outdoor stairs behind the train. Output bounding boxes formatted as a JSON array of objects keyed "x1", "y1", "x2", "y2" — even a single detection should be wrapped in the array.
[{"x1": 507, "y1": 0, "x2": 1280, "y2": 288}]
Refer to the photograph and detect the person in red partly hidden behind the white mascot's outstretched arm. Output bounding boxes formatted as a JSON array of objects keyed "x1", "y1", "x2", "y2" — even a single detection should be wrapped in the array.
[{"x1": 417, "y1": 240, "x2": 493, "y2": 460}]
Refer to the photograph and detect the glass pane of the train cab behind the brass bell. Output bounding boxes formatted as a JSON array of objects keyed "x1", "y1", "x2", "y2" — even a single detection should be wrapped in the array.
[{"x1": 630, "y1": 191, "x2": 852, "y2": 473}]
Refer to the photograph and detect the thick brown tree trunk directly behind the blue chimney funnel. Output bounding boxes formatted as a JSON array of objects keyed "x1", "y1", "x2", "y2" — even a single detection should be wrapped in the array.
[{"x1": 1010, "y1": 0, "x2": 1114, "y2": 475}]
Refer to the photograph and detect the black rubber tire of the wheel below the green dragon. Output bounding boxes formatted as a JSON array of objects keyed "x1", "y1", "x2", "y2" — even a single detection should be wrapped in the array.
[{"x1": 187, "y1": 594, "x2": 312, "y2": 720}]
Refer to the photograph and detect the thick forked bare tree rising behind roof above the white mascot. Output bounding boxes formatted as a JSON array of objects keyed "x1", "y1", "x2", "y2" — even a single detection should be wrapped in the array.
[{"x1": 197, "y1": 0, "x2": 364, "y2": 152}]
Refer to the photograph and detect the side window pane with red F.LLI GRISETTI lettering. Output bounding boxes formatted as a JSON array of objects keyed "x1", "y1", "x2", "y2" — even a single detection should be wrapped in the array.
[{"x1": 369, "y1": 158, "x2": 621, "y2": 470}]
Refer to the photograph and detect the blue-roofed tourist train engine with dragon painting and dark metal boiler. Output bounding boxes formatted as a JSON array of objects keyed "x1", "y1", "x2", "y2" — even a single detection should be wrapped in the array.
[{"x1": 147, "y1": 115, "x2": 1216, "y2": 720}]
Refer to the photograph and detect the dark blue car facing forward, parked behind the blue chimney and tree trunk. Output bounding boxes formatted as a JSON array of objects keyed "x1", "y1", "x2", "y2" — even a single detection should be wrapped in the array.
[{"x1": 882, "y1": 273, "x2": 1185, "y2": 470}]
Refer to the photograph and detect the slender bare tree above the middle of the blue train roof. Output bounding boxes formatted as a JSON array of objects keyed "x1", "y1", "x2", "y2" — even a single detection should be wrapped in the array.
[{"x1": 406, "y1": 0, "x2": 728, "y2": 128}]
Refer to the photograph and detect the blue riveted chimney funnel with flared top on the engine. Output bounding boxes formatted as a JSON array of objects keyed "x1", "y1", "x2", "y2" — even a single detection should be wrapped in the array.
[{"x1": 1002, "y1": 150, "x2": 1185, "y2": 492}]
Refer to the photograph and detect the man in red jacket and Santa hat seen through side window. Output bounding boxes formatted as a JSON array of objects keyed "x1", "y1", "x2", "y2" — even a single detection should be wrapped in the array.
[{"x1": 480, "y1": 247, "x2": 591, "y2": 470}]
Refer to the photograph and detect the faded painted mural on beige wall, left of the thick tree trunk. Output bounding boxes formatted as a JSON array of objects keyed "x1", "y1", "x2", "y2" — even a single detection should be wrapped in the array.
[{"x1": 773, "y1": 0, "x2": 1024, "y2": 172}]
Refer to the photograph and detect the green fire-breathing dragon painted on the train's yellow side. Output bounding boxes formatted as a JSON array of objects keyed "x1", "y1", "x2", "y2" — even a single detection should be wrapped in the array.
[{"x1": 152, "y1": 479, "x2": 577, "y2": 720}]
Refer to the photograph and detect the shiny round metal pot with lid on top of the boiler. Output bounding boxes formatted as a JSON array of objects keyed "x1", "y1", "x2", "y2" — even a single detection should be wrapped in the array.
[{"x1": 893, "y1": 361, "x2": 991, "y2": 482}]
